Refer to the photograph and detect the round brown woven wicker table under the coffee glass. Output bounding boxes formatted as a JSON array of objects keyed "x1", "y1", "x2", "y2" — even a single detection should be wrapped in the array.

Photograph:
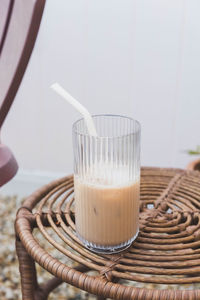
[{"x1": 15, "y1": 168, "x2": 200, "y2": 300}]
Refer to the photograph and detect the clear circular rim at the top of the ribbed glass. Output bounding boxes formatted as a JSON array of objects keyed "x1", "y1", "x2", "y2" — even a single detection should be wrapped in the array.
[{"x1": 72, "y1": 114, "x2": 141, "y2": 139}]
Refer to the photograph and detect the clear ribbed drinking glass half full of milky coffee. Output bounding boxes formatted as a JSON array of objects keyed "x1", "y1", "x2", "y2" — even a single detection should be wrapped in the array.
[{"x1": 73, "y1": 115, "x2": 140, "y2": 253}]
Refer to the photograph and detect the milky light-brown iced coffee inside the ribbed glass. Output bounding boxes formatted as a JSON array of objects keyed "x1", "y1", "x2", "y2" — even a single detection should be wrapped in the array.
[{"x1": 74, "y1": 176, "x2": 139, "y2": 246}]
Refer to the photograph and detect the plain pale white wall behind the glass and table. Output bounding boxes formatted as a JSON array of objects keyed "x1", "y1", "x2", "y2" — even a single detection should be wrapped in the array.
[{"x1": 2, "y1": 0, "x2": 200, "y2": 196}]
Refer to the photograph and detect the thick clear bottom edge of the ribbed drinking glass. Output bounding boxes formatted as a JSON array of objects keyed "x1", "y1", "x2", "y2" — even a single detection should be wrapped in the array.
[{"x1": 77, "y1": 231, "x2": 139, "y2": 254}]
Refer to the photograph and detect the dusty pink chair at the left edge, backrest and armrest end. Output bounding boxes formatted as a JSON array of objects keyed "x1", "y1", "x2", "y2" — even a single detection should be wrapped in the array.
[{"x1": 0, "y1": 0, "x2": 45, "y2": 186}]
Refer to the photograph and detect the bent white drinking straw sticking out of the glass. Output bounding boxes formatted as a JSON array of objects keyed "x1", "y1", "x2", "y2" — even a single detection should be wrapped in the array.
[{"x1": 51, "y1": 82, "x2": 97, "y2": 136}]
